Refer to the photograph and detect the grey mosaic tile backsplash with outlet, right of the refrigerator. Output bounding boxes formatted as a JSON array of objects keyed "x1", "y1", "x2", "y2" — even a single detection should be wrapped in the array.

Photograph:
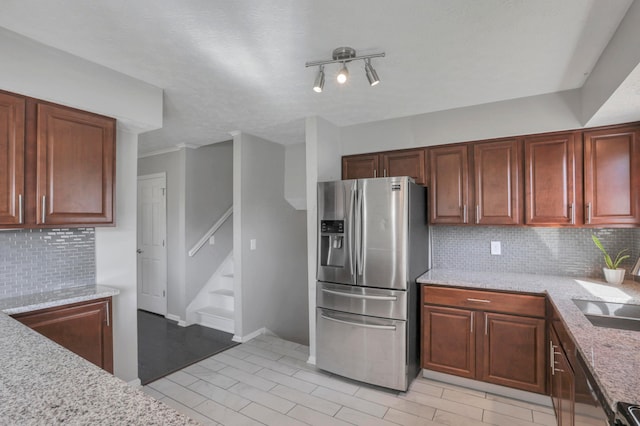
[{"x1": 431, "y1": 226, "x2": 640, "y2": 278}]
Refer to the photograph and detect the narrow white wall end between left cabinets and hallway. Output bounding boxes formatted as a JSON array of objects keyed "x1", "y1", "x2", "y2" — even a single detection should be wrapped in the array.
[{"x1": 96, "y1": 129, "x2": 138, "y2": 381}]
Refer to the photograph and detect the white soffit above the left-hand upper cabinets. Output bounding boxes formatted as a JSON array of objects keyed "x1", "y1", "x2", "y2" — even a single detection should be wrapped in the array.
[{"x1": 0, "y1": 27, "x2": 162, "y2": 133}]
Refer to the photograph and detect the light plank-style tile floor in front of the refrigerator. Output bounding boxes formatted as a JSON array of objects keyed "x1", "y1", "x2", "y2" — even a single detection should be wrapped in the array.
[{"x1": 143, "y1": 335, "x2": 556, "y2": 426}]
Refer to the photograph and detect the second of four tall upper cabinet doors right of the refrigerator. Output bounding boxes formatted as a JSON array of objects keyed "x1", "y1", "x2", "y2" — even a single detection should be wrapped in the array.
[{"x1": 473, "y1": 140, "x2": 522, "y2": 225}]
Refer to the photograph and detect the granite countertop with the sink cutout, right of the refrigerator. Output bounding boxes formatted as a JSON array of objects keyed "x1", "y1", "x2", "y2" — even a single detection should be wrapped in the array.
[{"x1": 417, "y1": 269, "x2": 640, "y2": 411}]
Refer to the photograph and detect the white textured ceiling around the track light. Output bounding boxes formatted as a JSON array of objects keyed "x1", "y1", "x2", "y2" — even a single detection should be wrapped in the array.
[{"x1": 0, "y1": 0, "x2": 638, "y2": 152}]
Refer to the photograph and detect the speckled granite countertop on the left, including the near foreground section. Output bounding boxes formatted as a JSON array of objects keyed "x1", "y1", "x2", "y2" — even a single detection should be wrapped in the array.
[{"x1": 0, "y1": 286, "x2": 198, "y2": 426}]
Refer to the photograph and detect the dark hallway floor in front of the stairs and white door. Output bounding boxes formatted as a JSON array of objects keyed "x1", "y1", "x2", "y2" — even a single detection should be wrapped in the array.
[{"x1": 138, "y1": 310, "x2": 237, "y2": 385}]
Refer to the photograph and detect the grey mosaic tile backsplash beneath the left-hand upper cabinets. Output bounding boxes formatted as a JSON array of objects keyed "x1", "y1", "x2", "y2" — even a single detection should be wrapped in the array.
[{"x1": 0, "y1": 228, "x2": 96, "y2": 298}]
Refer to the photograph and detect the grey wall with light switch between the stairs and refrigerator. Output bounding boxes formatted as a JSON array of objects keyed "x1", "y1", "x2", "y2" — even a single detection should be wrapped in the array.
[{"x1": 233, "y1": 133, "x2": 309, "y2": 344}]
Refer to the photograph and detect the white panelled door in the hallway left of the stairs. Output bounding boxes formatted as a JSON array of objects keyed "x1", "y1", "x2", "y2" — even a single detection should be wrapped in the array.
[{"x1": 138, "y1": 173, "x2": 167, "y2": 315}]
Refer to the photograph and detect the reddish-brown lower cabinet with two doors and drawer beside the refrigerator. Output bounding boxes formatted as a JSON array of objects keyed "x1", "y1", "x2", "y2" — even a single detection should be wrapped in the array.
[{"x1": 422, "y1": 286, "x2": 547, "y2": 394}]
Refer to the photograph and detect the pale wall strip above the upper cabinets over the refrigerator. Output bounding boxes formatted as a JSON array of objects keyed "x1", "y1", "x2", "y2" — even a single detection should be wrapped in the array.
[{"x1": 340, "y1": 90, "x2": 582, "y2": 155}]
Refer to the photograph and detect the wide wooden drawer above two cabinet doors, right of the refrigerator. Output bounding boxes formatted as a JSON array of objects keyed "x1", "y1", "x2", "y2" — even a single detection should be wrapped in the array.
[{"x1": 422, "y1": 286, "x2": 545, "y2": 318}]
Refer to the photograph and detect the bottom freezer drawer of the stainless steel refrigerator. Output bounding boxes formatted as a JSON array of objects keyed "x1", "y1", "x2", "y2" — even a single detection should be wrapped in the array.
[{"x1": 316, "y1": 308, "x2": 409, "y2": 391}]
